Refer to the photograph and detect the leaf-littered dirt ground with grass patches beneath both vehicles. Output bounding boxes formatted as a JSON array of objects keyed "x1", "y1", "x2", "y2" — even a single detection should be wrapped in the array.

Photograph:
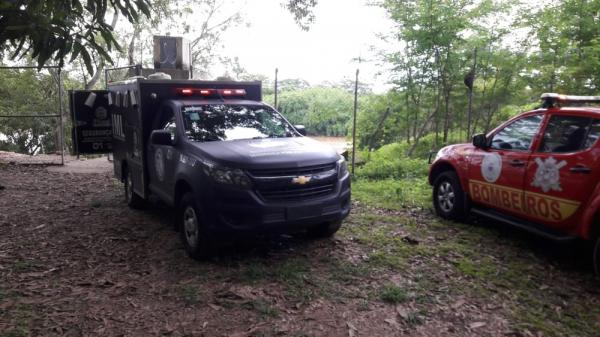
[{"x1": 0, "y1": 164, "x2": 600, "y2": 337}]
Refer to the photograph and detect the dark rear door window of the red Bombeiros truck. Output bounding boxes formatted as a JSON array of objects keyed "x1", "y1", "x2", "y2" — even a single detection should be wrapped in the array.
[{"x1": 539, "y1": 115, "x2": 593, "y2": 153}]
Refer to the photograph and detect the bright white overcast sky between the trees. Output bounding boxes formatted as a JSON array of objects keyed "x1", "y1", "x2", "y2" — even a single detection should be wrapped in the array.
[{"x1": 214, "y1": 0, "x2": 392, "y2": 92}]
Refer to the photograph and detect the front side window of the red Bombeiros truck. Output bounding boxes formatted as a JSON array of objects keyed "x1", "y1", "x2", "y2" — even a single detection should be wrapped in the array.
[{"x1": 491, "y1": 115, "x2": 544, "y2": 151}]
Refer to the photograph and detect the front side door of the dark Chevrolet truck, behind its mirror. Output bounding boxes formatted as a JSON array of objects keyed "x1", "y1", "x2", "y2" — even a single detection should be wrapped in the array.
[{"x1": 147, "y1": 106, "x2": 179, "y2": 200}]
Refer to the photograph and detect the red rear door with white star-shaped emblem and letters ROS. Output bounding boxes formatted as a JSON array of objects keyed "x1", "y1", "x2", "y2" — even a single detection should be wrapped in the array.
[{"x1": 524, "y1": 111, "x2": 600, "y2": 231}]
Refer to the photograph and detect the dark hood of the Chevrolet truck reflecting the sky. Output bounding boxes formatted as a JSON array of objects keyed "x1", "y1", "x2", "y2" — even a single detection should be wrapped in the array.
[{"x1": 191, "y1": 137, "x2": 340, "y2": 169}]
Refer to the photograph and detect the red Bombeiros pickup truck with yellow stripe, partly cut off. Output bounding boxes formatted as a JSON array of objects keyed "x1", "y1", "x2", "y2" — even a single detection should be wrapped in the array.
[{"x1": 429, "y1": 93, "x2": 600, "y2": 274}]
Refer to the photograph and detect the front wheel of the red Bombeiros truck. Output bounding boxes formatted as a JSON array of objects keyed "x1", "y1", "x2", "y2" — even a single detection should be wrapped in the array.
[{"x1": 433, "y1": 171, "x2": 466, "y2": 221}]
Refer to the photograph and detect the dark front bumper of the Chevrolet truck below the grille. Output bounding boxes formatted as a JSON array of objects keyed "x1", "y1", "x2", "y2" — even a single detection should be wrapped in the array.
[{"x1": 203, "y1": 174, "x2": 351, "y2": 233}]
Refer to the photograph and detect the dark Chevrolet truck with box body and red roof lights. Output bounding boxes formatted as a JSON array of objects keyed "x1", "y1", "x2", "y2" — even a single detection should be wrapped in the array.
[{"x1": 73, "y1": 79, "x2": 350, "y2": 258}]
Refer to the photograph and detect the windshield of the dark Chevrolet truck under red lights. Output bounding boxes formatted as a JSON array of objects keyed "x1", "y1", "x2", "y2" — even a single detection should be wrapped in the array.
[{"x1": 181, "y1": 104, "x2": 297, "y2": 142}]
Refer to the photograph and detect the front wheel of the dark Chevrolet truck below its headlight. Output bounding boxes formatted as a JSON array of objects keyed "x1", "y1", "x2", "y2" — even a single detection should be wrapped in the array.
[{"x1": 177, "y1": 192, "x2": 214, "y2": 260}]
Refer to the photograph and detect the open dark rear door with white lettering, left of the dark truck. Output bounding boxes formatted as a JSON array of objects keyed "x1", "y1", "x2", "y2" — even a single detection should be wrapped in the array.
[{"x1": 69, "y1": 90, "x2": 113, "y2": 155}]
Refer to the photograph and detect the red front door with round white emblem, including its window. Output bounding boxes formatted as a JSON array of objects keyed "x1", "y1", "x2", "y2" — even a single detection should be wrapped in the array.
[{"x1": 469, "y1": 113, "x2": 544, "y2": 215}]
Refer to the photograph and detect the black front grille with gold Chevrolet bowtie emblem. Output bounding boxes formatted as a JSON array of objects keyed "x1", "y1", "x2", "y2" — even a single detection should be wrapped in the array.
[{"x1": 249, "y1": 163, "x2": 337, "y2": 201}]
